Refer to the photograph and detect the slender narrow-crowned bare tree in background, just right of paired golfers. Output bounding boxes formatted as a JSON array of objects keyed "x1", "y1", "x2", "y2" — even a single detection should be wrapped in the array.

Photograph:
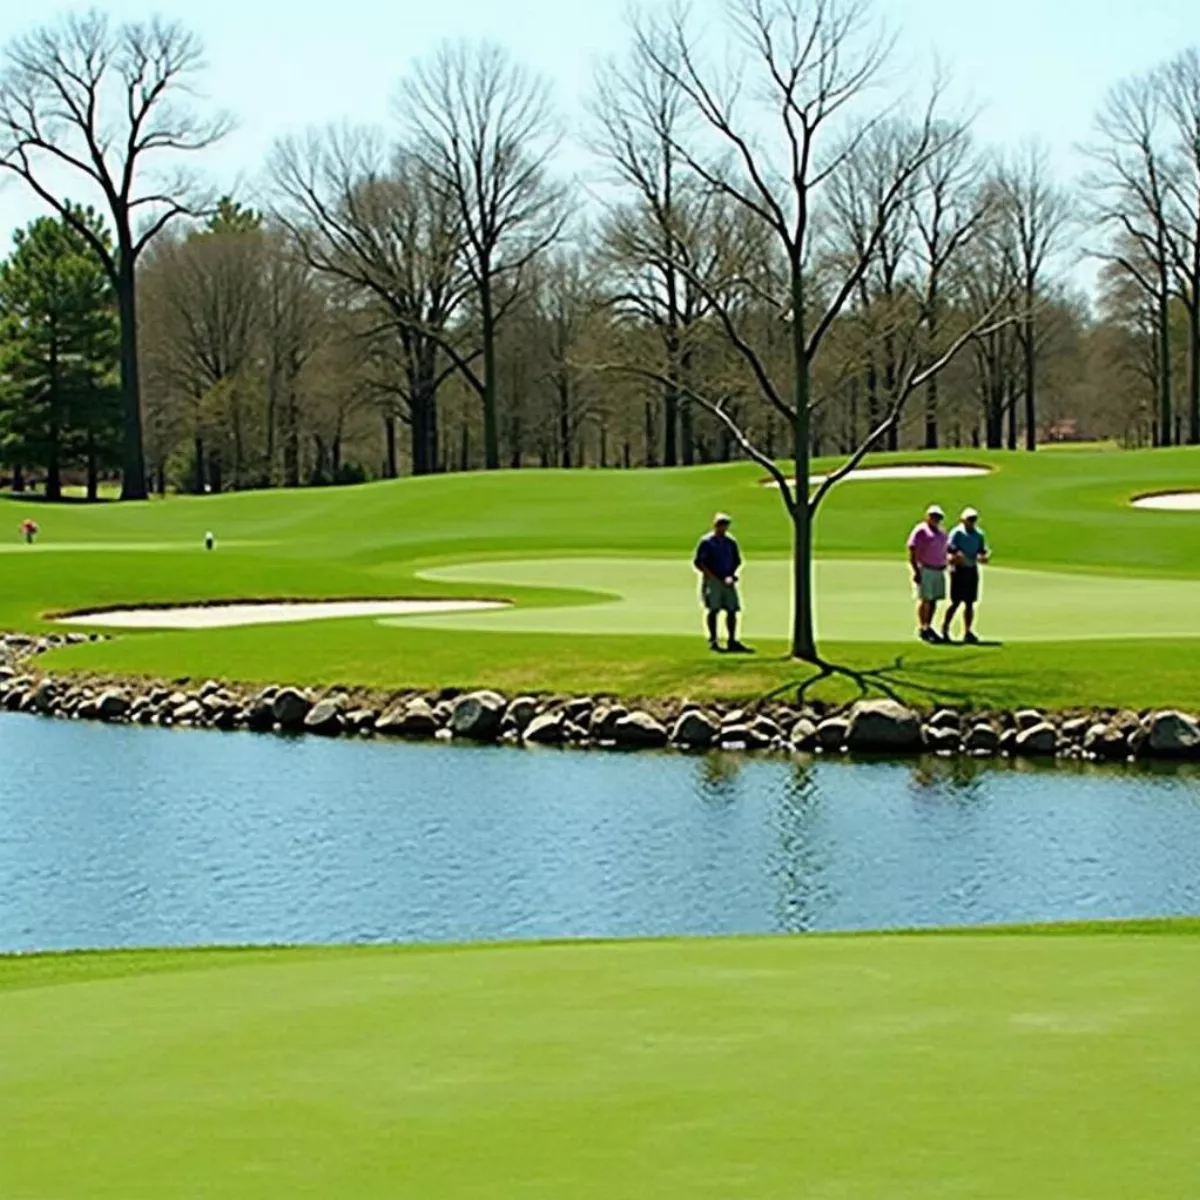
[{"x1": 997, "y1": 142, "x2": 1070, "y2": 450}]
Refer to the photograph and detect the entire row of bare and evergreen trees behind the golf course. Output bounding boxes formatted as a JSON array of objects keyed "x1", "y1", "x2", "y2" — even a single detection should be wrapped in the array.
[{"x1": 0, "y1": 0, "x2": 1200, "y2": 501}]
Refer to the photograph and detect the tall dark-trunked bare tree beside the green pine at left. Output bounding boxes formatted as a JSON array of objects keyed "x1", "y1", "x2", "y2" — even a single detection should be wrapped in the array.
[{"x1": 0, "y1": 12, "x2": 229, "y2": 499}]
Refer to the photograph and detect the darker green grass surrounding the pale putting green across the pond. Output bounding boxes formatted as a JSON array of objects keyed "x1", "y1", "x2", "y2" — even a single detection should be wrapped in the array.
[{"x1": 0, "y1": 450, "x2": 1200, "y2": 707}]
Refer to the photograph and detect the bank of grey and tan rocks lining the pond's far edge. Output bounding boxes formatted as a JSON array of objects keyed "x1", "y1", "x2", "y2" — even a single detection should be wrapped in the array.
[{"x1": 0, "y1": 634, "x2": 1200, "y2": 762}]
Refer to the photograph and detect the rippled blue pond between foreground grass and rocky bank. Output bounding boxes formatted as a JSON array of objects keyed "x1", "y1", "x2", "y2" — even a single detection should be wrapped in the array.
[{"x1": 0, "y1": 714, "x2": 1200, "y2": 950}]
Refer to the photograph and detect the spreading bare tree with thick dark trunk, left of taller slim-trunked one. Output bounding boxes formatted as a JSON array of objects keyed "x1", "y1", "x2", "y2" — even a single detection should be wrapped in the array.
[{"x1": 272, "y1": 130, "x2": 468, "y2": 475}]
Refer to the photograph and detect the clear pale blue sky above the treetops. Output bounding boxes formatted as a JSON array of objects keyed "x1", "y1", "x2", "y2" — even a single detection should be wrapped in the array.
[{"x1": 0, "y1": 0, "x2": 1200, "y2": 248}]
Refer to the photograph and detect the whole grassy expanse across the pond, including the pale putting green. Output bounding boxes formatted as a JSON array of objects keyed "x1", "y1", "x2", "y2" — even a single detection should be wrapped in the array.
[{"x1": 7, "y1": 448, "x2": 1200, "y2": 707}]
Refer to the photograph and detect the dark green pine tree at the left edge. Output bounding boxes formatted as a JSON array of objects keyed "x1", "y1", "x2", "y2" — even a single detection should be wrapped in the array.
[{"x1": 0, "y1": 209, "x2": 121, "y2": 499}]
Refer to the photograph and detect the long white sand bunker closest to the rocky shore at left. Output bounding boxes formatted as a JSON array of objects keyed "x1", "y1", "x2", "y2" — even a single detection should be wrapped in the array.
[{"x1": 59, "y1": 600, "x2": 508, "y2": 629}]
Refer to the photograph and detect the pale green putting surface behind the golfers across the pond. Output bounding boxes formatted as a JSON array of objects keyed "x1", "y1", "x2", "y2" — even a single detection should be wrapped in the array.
[{"x1": 398, "y1": 558, "x2": 1200, "y2": 642}]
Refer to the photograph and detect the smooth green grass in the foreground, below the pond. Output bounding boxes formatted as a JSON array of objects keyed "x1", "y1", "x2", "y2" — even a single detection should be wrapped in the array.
[{"x1": 0, "y1": 924, "x2": 1200, "y2": 1200}]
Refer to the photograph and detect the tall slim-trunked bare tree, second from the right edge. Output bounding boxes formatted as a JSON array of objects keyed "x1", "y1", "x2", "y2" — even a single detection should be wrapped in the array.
[{"x1": 1085, "y1": 76, "x2": 1176, "y2": 445}]
